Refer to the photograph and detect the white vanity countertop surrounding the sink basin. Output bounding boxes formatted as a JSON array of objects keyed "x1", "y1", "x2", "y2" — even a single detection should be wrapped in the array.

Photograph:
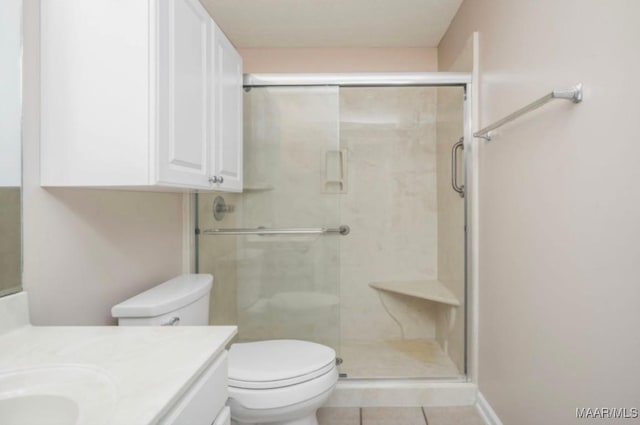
[{"x1": 0, "y1": 325, "x2": 236, "y2": 425}]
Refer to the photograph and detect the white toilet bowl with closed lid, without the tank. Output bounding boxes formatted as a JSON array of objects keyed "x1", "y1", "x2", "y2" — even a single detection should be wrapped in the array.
[{"x1": 229, "y1": 340, "x2": 338, "y2": 425}]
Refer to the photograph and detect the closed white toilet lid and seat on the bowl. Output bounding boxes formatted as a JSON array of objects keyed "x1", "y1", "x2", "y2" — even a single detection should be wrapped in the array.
[{"x1": 229, "y1": 340, "x2": 336, "y2": 389}]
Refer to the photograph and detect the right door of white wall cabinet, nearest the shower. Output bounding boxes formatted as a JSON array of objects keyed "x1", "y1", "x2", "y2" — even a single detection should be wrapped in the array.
[{"x1": 211, "y1": 25, "x2": 242, "y2": 192}]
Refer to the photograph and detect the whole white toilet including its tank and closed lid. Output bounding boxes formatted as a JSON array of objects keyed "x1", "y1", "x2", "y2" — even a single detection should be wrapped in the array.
[{"x1": 111, "y1": 274, "x2": 338, "y2": 425}]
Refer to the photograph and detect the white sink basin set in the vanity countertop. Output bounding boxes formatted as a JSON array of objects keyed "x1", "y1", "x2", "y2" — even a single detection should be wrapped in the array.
[{"x1": 0, "y1": 365, "x2": 117, "y2": 425}]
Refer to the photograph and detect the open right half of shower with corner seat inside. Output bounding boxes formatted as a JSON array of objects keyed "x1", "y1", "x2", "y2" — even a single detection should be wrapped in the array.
[{"x1": 340, "y1": 86, "x2": 465, "y2": 379}]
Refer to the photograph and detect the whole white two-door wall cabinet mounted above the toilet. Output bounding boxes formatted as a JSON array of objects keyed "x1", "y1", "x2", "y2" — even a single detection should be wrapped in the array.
[{"x1": 40, "y1": 0, "x2": 242, "y2": 191}]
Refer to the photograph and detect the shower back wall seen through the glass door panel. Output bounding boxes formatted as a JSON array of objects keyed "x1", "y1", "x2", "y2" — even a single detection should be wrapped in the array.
[{"x1": 238, "y1": 87, "x2": 340, "y2": 348}]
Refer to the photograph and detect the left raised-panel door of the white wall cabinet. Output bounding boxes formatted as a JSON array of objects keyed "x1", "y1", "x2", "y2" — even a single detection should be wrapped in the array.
[{"x1": 156, "y1": 0, "x2": 214, "y2": 188}]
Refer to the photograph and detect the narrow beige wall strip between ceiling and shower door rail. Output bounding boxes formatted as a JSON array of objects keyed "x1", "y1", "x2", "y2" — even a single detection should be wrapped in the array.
[{"x1": 239, "y1": 48, "x2": 438, "y2": 73}]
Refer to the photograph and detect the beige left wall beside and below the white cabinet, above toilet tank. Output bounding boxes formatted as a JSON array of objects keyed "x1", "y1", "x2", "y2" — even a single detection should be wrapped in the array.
[{"x1": 23, "y1": 0, "x2": 183, "y2": 325}]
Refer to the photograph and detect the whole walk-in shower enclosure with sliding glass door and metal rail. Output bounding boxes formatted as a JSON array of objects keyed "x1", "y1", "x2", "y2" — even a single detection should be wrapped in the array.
[{"x1": 196, "y1": 74, "x2": 469, "y2": 380}]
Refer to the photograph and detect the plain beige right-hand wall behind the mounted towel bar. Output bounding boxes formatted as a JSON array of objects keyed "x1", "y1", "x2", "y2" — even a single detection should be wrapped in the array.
[{"x1": 439, "y1": 0, "x2": 640, "y2": 425}]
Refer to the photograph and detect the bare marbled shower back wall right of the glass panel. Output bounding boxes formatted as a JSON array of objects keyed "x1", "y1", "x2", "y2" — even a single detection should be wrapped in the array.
[{"x1": 340, "y1": 87, "x2": 438, "y2": 341}]
